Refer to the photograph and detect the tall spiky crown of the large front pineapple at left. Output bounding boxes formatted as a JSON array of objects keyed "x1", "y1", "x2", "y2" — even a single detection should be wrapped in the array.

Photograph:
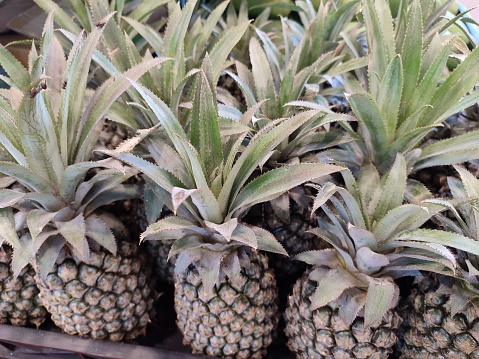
[{"x1": 0, "y1": 14, "x2": 162, "y2": 275}]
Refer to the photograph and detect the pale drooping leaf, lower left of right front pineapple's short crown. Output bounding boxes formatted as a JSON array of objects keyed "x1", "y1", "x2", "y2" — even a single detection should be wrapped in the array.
[{"x1": 310, "y1": 267, "x2": 363, "y2": 310}]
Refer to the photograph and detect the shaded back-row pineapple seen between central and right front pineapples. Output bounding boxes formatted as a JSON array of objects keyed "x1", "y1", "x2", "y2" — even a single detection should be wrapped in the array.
[{"x1": 229, "y1": 19, "x2": 360, "y2": 281}]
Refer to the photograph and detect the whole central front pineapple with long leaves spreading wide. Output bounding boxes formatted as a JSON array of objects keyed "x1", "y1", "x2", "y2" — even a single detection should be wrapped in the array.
[{"x1": 105, "y1": 57, "x2": 340, "y2": 358}]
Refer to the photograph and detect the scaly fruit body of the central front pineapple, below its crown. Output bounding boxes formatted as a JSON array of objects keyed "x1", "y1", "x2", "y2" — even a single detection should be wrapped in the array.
[{"x1": 175, "y1": 252, "x2": 279, "y2": 359}]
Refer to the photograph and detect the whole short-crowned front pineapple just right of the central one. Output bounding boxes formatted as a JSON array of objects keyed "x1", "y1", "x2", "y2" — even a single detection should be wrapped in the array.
[{"x1": 285, "y1": 155, "x2": 479, "y2": 358}]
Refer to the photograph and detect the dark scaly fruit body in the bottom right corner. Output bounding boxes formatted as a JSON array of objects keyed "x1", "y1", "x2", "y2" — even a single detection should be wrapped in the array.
[{"x1": 401, "y1": 276, "x2": 479, "y2": 359}]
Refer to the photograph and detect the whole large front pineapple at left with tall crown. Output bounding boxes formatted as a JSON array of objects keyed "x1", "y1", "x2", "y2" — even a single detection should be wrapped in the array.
[{"x1": 0, "y1": 14, "x2": 162, "y2": 340}]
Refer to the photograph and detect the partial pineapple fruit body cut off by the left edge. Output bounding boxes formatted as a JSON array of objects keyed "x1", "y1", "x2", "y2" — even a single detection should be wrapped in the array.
[{"x1": 0, "y1": 246, "x2": 47, "y2": 327}]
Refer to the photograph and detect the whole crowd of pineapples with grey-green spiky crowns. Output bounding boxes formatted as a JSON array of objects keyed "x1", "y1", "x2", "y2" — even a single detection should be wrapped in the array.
[{"x1": 0, "y1": 0, "x2": 479, "y2": 358}]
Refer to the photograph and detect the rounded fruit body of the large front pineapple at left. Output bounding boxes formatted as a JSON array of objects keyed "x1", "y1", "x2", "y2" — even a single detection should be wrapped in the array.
[{"x1": 36, "y1": 242, "x2": 154, "y2": 341}]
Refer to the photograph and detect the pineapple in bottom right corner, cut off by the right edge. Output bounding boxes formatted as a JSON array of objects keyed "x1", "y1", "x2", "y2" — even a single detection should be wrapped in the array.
[{"x1": 401, "y1": 166, "x2": 479, "y2": 359}]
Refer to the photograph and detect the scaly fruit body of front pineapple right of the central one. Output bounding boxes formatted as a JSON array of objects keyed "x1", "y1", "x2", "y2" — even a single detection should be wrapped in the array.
[{"x1": 284, "y1": 270, "x2": 401, "y2": 359}]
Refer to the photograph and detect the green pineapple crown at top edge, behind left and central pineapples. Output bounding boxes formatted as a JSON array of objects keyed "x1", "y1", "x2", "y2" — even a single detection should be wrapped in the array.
[{"x1": 43, "y1": 0, "x2": 249, "y2": 129}]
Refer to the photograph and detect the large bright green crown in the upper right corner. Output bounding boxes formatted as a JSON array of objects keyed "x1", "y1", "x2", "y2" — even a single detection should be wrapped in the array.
[{"x1": 318, "y1": 0, "x2": 479, "y2": 173}]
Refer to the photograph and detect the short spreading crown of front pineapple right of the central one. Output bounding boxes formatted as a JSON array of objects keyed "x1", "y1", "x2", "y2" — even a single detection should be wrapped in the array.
[{"x1": 295, "y1": 155, "x2": 479, "y2": 326}]
